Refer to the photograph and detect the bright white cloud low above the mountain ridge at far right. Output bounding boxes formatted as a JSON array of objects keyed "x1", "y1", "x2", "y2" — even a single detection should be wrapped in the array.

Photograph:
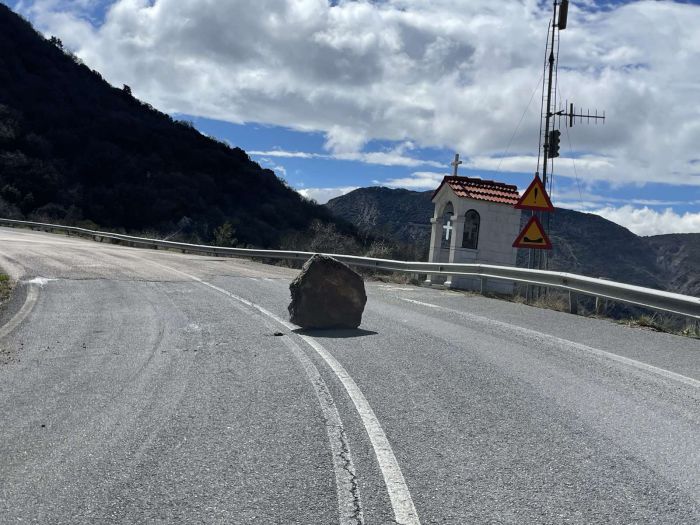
[{"x1": 592, "y1": 205, "x2": 700, "y2": 235}]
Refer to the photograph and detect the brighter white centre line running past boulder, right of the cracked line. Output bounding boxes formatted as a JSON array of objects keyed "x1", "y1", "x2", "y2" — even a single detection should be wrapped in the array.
[{"x1": 147, "y1": 260, "x2": 420, "y2": 525}]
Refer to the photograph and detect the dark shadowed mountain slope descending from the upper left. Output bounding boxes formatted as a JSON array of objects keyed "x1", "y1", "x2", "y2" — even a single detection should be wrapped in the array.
[{"x1": 0, "y1": 4, "x2": 344, "y2": 247}]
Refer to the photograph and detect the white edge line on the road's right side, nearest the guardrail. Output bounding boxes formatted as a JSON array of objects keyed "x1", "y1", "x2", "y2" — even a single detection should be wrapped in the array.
[{"x1": 400, "y1": 297, "x2": 700, "y2": 388}]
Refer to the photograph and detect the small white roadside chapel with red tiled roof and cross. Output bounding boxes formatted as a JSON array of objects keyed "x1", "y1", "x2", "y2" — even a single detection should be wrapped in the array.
[{"x1": 426, "y1": 155, "x2": 521, "y2": 294}]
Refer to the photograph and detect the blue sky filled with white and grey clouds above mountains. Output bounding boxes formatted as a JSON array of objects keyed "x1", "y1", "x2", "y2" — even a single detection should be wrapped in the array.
[{"x1": 10, "y1": 0, "x2": 700, "y2": 234}]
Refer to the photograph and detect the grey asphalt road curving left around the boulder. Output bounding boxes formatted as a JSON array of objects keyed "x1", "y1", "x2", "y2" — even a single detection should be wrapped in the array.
[{"x1": 0, "y1": 229, "x2": 700, "y2": 525}]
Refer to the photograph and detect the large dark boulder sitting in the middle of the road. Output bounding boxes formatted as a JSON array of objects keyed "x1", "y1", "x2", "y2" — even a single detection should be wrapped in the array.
[{"x1": 289, "y1": 254, "x2": 367, "y2": 328}]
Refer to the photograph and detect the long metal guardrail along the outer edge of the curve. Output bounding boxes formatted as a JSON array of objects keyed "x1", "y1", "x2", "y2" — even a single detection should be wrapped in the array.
[{"x1": 0, "y1": 218, "x2": 700, "y2": 319}]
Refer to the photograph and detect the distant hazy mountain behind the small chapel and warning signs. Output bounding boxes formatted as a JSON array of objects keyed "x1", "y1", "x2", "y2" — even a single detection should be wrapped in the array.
[{"x1": 326, "y1": 187, "x2": 700, "y2": 296}]
